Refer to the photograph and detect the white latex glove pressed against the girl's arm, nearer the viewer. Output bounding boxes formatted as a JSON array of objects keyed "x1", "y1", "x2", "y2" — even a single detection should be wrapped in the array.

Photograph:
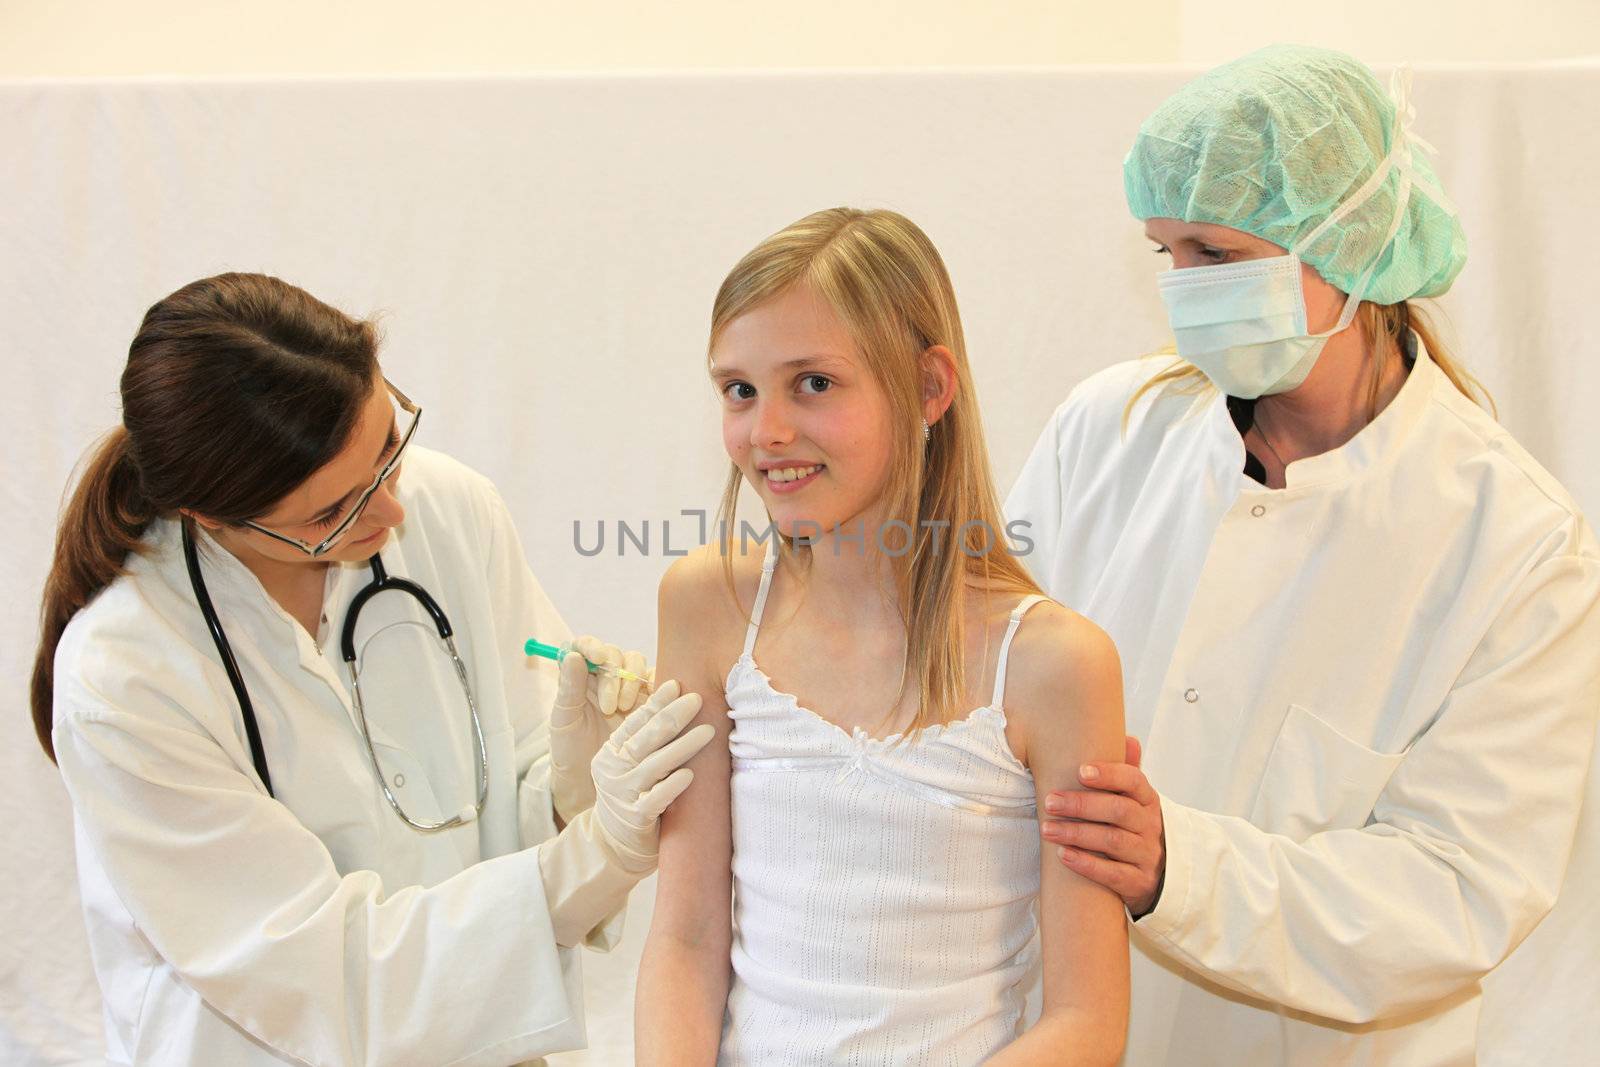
[{"x1": 539, "y1": 681, "x2": 717, "y2": 945}]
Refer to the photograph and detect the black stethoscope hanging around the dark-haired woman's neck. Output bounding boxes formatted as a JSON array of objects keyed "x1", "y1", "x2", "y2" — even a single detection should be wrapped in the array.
[{"x1": 182, "y1": 523, "x2": 490, "y2": 832}]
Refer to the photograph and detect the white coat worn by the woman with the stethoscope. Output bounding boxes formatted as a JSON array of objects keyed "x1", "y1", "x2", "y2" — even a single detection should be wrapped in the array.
[{"x1": 54, "y1": 448, "x2": 614, "y2": 1067}]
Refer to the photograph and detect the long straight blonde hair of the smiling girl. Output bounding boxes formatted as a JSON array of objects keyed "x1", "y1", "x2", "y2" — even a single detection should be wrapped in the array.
[{"x1": 710, "y1": 208, "x2": 1040, "y2": 737}]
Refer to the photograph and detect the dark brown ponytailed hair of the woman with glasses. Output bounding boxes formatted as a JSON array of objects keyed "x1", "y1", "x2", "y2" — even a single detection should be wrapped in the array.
[{"x1": 32, "y1": 274, "x2": 379, "y2": 760}]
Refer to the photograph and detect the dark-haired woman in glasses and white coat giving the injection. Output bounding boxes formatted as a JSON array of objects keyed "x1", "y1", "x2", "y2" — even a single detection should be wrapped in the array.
[{"x1": 32, "y1": 274, "x2": 709, "y2": 1067}]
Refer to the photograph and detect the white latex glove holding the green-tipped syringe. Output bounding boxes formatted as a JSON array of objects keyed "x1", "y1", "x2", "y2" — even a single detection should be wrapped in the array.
[{"x1": 550, "y1": 637, "x2": 645, "y2": 822}]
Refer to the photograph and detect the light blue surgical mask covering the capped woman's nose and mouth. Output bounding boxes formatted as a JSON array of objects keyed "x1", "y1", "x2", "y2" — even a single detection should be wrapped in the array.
[{"x1": 1158, "y1": 251, "x2": 1362, "y2": 400}]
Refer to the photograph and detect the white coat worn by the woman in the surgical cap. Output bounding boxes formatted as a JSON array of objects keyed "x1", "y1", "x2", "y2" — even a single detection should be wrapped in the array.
[{"x1": 1006, "y1": 352, "x2": 1600, "y2": 1067}]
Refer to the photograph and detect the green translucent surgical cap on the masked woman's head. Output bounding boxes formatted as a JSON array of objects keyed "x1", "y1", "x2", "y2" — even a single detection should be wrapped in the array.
[{"x1": 1122, "y1": 45, "x2": 1467, "y2": 304}]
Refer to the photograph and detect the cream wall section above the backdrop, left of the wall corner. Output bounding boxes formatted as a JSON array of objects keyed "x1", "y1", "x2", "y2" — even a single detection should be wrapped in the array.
[{"x1": 0, "y1": 0, "x2": 1179, "y2": 75}]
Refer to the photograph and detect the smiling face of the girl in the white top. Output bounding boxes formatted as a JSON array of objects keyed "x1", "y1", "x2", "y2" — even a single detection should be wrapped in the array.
[{"x1": 710, "y1": 283, "x2": 893, "y2": 544}]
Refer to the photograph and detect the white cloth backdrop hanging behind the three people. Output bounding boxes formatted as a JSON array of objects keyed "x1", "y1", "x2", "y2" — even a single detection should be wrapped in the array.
[{"x1": 0, "y1": 62, "x2": 1600, "y2": 1064}]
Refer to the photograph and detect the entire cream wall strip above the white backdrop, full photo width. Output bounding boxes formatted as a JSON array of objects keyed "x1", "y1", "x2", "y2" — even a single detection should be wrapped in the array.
[{"x1": 0, "y1": 0, "x2": 1600, "y2": 77}]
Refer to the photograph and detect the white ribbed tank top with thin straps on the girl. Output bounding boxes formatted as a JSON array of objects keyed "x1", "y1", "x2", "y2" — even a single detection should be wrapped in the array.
[{"x1": 718, "y1": 545, "x2": 1043, "y2": 1067}]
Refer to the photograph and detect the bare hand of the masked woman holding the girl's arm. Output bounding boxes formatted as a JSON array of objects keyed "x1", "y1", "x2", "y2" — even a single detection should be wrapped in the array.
[{"x1": 1040, "y1": 737, "x2": 1166, "y2": 918}]
